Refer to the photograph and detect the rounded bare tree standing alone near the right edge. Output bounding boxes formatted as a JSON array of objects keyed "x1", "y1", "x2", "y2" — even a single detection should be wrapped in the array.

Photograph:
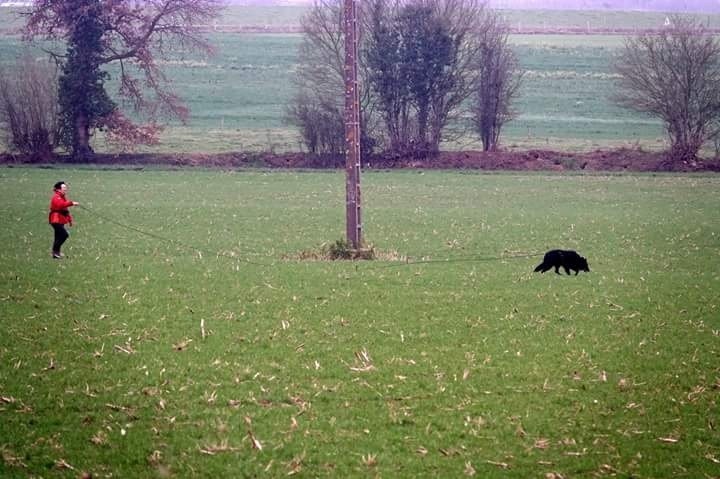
[{"x1": 613, "y1": 15, "x2": 720, "y2": 163}]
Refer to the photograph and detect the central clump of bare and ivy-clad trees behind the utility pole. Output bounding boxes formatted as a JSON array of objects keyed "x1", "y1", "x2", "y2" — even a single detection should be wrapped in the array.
[{"x1": 288, "y1": 0, "x2": 523, "y2": 162}]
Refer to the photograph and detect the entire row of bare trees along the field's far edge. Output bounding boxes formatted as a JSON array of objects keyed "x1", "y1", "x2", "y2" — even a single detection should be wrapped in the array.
[{"x1": 0, "y1": 0, "x2": 720, "y2": 164}]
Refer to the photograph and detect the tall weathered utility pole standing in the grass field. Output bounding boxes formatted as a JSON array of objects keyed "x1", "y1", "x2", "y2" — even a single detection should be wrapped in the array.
[{"x1": 344, "y1": 0, "x2": 362, "y2": 249}]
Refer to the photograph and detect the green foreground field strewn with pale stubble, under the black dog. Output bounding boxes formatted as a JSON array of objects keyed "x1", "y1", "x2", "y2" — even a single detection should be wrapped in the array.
[{"x1": 0, "y1": 168, "x2": 720, "y2": 478}]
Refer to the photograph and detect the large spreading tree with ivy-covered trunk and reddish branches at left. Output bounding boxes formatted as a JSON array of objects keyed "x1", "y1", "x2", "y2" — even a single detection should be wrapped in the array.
[{"x1": 25, "y1": 0, "x2": 221, "y2": 158}]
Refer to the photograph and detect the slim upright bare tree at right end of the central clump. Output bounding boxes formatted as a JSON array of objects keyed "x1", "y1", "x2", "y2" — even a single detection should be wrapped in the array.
[{"x1": 473, "y1": 14, "x2": 523, "y2": 151}]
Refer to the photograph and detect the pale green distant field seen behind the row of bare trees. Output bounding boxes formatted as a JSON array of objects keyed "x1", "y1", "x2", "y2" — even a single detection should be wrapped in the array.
[{"x1": 0, "y1": 7, "x2": 720, "y2": 152}]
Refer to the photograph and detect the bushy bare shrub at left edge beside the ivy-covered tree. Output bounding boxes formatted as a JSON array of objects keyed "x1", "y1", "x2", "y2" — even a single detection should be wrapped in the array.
[{"x1": 0, "y1": 55, "x2": 59, "y2": 161}]
